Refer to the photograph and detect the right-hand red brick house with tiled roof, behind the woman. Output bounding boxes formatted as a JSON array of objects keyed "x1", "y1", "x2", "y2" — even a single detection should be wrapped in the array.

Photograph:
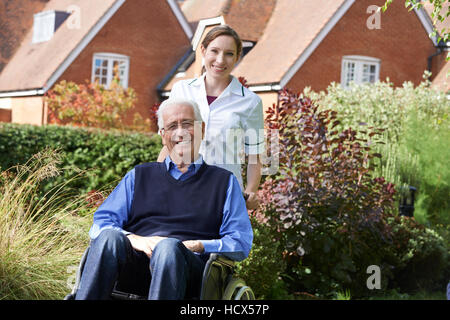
[{"x1": 160, "y1": 0, "x2": 450, "y2": 112}]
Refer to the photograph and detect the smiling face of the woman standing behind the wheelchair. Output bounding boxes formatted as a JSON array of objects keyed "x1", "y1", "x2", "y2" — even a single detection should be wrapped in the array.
[{"x1": 201, "y1": 35, "x2": 239, "y2": 79}]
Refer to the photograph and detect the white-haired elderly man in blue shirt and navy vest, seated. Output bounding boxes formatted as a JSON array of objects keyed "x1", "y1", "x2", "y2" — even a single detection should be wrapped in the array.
[{"x1": 75, "y1": 99, "x2": 253, "y2": 299}]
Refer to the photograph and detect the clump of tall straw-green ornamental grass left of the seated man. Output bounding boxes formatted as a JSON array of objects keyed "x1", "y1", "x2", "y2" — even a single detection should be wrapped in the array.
[{"x1": 0, "y1": 150, "x2": 88, "y2": 300}]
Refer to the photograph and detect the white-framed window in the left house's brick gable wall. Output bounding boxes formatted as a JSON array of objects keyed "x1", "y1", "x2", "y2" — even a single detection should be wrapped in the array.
[{"x1": 92, "y1": 53, "x2": 130, "y2": 88}]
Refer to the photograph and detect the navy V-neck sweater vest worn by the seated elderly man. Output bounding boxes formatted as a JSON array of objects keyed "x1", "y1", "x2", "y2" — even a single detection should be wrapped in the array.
[{"x1": 124, "y1": 162, "x2": 231, "y2": 241}]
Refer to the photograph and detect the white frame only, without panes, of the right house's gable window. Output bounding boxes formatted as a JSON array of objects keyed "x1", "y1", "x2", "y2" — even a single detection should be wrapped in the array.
[{"x1": 341, "y1": 56, "x2": 381, "y2": 88}]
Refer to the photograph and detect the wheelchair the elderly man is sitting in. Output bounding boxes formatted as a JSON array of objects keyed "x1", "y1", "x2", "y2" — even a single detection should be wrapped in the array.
[{"x1": 64, "y1": 247, "x2": 255, "y2": 300}]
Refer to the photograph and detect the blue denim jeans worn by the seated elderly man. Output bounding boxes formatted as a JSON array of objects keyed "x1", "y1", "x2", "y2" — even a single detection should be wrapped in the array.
[{"x1": 75, "y1": 229, "x2": 206, "y2": 300}]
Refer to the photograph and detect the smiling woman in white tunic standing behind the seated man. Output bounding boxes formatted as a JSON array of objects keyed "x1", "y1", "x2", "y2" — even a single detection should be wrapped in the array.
[{"x1": 158, "y1": 25, "x2": 264, "y2": 209}]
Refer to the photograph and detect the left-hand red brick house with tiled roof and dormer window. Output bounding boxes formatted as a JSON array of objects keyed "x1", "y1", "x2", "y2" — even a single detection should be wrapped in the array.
[{"x1": 0, "y1": 0, "x2": 192, "y2": 124}]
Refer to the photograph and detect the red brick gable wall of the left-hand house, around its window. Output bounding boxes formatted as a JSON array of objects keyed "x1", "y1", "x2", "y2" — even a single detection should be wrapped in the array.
[{"x1": 58, "y1": 0, "x2": 190, "y2": 127}]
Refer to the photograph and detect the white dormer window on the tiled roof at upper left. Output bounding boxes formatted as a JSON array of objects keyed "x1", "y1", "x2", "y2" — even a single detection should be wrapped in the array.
[{"x1": 32, "y1": 11, "x2": 70, "y2": 43}]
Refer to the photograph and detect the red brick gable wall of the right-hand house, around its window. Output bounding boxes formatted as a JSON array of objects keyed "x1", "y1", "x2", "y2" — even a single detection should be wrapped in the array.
[{"x1": 286, "y1": 0, "x2": 435, "y2": 91}]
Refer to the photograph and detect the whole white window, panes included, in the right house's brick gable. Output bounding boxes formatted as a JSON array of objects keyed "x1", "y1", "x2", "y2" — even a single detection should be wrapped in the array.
[{"x1": 341, "y1": 56, "x2": 380, "y2": 88}]
